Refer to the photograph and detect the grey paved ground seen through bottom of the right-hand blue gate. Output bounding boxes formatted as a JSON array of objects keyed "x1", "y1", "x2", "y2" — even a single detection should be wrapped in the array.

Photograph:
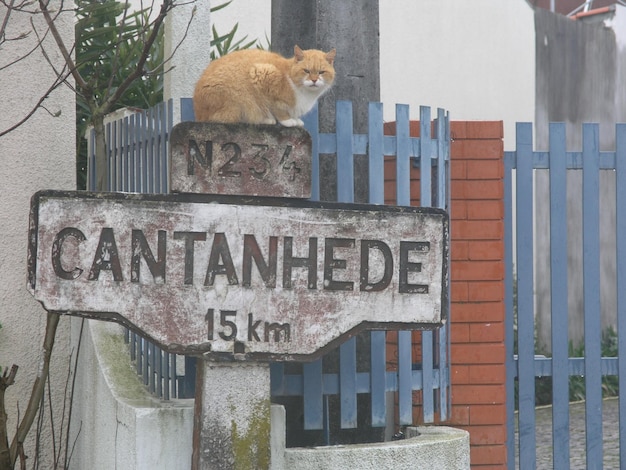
[{"x1": 515, "y1": 398, "x2": 620, "y2": 470}]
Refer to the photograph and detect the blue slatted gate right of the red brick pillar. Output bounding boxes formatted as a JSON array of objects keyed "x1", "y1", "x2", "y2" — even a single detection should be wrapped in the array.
[{"x1": 505, "y1": 123, "x2": 626, "y2": 470}]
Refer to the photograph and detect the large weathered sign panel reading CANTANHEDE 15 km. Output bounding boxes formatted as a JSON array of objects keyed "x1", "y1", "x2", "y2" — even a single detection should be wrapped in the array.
[{"x1": 28, "y1": 191, "x2": 448, "y2": 360}]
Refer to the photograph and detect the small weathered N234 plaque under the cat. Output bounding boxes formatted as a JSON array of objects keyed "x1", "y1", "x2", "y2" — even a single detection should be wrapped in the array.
[{"x1": 170, "y1": 122, "x2": 311, "y2": 199}]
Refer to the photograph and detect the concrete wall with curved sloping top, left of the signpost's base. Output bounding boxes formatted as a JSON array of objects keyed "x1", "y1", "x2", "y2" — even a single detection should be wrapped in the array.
[{"x1": 70, "y1": 320, "x2": 193, "y2": 470}]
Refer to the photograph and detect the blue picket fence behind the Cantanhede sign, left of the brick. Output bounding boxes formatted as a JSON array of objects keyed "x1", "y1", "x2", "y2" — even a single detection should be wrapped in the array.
[{"x1": 89, "y1": 99, "x2": 450, "y2": 436}]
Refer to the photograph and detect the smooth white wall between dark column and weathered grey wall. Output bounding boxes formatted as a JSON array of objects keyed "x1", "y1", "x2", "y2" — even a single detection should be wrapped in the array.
[{"x1": 380, "y1": 0, "x2": 535, "y2": 148}]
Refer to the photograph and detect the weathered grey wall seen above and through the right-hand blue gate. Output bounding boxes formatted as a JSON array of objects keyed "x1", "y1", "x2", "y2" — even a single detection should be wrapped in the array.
[{"x1": 535, "y1": 5, "x2": 626, "y2": 350}]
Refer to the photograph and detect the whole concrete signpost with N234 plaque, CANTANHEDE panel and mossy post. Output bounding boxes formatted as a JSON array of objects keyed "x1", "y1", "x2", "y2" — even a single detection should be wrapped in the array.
[{"x1": 28, "y1": 123, "x2": 449, "y2": 470}]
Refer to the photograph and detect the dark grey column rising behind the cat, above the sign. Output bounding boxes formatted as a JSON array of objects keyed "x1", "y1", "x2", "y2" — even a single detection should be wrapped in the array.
[{"x1": 272, "y1": 0, "x2": 380, "y2": 202}]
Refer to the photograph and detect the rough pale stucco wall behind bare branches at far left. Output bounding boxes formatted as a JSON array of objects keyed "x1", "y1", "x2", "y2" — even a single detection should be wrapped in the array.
[{"x1": 0, "y1": 0, "x2": 76, "y2": 462}]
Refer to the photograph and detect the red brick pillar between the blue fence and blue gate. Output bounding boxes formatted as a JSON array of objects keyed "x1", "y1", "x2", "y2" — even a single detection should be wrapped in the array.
[{"x1": 385, "y1": 122, "x2": 507, "y2": 470}]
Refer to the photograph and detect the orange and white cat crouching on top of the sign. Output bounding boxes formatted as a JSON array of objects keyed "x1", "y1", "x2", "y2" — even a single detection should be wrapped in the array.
[{"x1": 193, "y1": 46, "x2": 336, "y2": 127}]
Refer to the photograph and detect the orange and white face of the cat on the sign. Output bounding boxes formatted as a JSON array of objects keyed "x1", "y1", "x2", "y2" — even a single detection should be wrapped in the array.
[{"x1": 290, "y1": 46, "x2": 335, "y2": 93}]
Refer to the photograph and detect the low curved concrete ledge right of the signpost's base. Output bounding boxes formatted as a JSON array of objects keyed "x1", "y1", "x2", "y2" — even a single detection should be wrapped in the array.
[{"x1": 281, "y1": 426, "x2": 470, "y2": 470}]
